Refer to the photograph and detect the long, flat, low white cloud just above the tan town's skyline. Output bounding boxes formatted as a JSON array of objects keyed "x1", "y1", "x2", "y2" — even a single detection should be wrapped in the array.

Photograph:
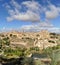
[{"x1": 20, "y1": 22, "x2": 60, "y2": 33}]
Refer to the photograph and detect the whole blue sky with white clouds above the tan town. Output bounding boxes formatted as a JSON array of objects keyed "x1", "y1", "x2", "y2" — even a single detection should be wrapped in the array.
[{"x1": 0, "y1": 0, "x2": 60, "y2": 32}]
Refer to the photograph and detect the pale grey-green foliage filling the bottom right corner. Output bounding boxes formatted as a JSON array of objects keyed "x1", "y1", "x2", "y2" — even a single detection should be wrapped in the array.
[{"x1": 44, "y1": 45, "x2": 60, "y2": 65}]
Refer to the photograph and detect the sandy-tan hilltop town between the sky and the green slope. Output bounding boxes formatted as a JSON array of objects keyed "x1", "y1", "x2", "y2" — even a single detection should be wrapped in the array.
[{"x1": 0, "y1": 30, "x2": 60, "y2": 49}]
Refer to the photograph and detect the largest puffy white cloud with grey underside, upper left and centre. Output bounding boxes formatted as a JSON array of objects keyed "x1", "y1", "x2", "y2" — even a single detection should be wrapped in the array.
[{"x1": 7, "y1": 0, "x2": 40, "y2": 22}]
